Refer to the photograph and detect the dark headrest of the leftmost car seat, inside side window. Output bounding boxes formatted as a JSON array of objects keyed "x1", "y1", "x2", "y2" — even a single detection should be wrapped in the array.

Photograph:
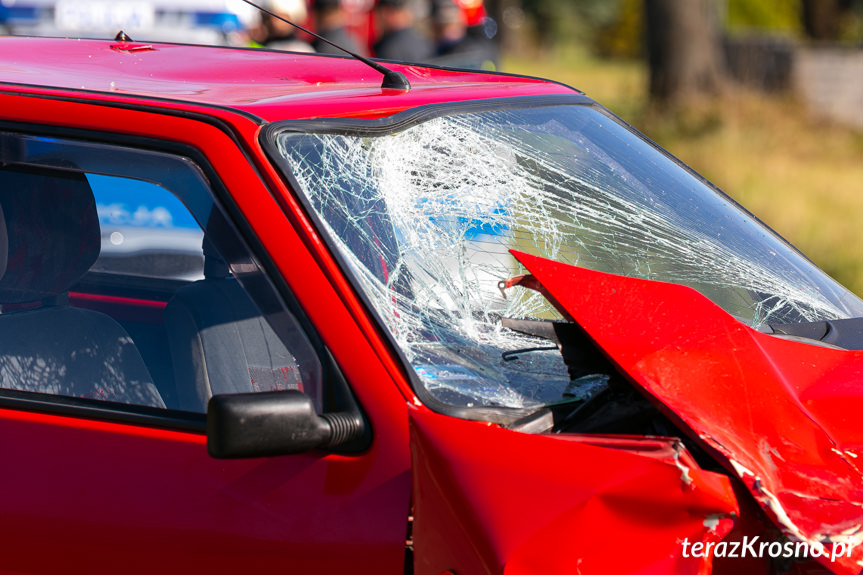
[{"x1": 0, "y1": 165, "x2": 101, "y2": 304}]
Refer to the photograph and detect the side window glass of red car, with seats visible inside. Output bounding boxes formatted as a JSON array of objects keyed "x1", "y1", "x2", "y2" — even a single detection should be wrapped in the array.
[{"x1": 0, "y1": 134, "x2": 322, "y2": 413}]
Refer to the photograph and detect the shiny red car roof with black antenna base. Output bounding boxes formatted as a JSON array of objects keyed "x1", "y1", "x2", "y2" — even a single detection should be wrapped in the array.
[{"x1": 0, "y1": 36, "x2": 576, "y2": 121}]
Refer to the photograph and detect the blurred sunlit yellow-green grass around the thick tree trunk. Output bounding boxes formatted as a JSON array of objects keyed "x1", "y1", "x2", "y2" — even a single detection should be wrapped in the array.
[{"x1": 503, "y1": 48, "x2": 863, "y2": 295}]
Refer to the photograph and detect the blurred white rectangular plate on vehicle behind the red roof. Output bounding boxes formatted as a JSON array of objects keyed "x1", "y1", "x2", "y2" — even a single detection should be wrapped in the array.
[{"x1": 54, "y1": 0, "x2": 156, "y2": 32}]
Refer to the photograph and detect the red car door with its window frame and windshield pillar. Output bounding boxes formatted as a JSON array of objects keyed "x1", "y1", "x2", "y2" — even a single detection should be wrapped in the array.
[{"x1": 0, "y1": 68, "x2": 418, "y2": 574}]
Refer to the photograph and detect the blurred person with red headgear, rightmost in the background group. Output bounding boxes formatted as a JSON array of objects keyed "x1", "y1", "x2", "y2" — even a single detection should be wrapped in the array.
[{"x1": 432, "y1": 0, "x2": 499, "y2": 70}]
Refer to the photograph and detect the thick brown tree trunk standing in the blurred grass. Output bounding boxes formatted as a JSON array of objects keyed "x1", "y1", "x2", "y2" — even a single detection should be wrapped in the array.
[{"x1": 644, "y1": 0, "x2": 726, "y2": 108}]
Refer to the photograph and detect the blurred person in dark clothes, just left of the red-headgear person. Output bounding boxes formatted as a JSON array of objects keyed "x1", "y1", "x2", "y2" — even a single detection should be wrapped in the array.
[{"x1": 372, "y1": 0, "x2": 434, "y2": 62}]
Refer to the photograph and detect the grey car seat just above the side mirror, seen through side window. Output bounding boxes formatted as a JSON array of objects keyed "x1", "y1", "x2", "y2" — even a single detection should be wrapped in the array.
[{"x1": 165, "y1": 235, "x2": 307, "y2": 412}]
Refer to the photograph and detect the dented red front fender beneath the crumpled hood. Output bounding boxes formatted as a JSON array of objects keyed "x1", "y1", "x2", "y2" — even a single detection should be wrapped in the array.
[{"x1": 410, "y1": 408, "x2": 739, "y2": 575}]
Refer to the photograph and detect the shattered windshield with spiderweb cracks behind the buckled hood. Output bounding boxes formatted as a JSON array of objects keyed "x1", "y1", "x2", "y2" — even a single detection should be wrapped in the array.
[{"x1": 277, "y1": 105, "x2": 863, "y2": 408}]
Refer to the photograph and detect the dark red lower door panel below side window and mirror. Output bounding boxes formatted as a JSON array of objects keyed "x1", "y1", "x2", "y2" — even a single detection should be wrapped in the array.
[{"x1": 0, "y1": 404, "x2": 407, "y2": 573}]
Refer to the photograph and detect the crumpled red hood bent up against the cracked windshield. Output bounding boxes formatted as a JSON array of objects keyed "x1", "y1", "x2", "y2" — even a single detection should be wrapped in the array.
[{"x1": 513, "y1": 252, "x2": 863, "y2": 574}]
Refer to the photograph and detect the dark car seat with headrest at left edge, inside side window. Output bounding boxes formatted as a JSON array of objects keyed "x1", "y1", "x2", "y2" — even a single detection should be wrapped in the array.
[{"x1": 0, "y1": 165, "x2": 165, "y2": 407}]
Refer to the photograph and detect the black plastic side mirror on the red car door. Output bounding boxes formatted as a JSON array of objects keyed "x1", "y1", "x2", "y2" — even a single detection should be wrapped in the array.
[{"x1": 207, "y1": 390, "x2": 366, "y2": 459}]
